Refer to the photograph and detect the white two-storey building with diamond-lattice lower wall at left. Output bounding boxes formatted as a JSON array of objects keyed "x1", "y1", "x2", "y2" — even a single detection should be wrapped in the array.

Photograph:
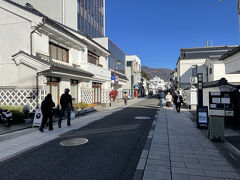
[{"x1": 0, "y1": 0, "x2": 111, "y2": 107}]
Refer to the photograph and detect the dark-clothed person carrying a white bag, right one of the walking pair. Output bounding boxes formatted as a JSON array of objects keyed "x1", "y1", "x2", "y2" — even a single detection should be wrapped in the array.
[{"x1": 58, "y1": 88, "x2": 73, "y2": 128}]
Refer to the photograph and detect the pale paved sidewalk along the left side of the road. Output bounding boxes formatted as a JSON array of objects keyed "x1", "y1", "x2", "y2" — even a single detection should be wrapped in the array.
[{"x1": 0, "y1": 98, "x2": 144, "y2": 162}]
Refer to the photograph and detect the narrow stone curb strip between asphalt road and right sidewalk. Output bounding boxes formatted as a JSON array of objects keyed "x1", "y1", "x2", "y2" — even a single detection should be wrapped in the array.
[{"x1": 133, "y1": 109, "x2": 160, "y2": 180}]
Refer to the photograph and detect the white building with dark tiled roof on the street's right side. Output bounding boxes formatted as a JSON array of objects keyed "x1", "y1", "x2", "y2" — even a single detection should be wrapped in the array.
[{"x1": 177, "y1": 46, "x2": 240, "y2": 109}]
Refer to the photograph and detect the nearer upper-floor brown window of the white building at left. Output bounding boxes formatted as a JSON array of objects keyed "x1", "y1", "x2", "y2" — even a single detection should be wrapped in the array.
[{"x1": 49, "y1": 43, "x2": 69, "y2": 63}]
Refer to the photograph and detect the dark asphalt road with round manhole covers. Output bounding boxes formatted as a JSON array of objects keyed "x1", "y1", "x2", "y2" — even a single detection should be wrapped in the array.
[{"x1": 0, "y1": 98, "x2": 158, "y2": 180}]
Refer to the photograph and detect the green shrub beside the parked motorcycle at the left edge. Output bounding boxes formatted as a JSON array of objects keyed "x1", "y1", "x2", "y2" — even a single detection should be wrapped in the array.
[{"x1": 0, "y1": 105, "x2": 24, "y2": 123}]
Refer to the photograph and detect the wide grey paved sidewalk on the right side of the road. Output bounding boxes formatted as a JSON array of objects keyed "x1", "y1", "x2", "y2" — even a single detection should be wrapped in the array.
[{"x1": 134, "y1": 108, "x2": 240, "y2": 180}]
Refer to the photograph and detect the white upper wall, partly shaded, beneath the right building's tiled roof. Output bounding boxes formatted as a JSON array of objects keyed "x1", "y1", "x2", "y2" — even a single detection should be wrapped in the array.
[{"x1": 179, "y1": 59, "x2": 207, "y2": 83}]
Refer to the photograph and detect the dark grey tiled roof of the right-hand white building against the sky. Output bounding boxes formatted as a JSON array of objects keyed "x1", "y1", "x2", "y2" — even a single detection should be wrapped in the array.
[{"x1": 179, "y1": 46, "x2": 237, "y2": 59}]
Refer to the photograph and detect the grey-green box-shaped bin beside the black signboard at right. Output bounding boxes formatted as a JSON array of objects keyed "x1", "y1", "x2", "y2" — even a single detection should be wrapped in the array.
[{"x1": 208, "y1": 116, "x2": 224, "y2": 141}]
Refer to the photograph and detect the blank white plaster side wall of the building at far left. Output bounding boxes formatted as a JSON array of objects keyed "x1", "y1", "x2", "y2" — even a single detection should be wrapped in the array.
[{"x1": 0, "y1": 5, "x2": 36, "y2": 87}]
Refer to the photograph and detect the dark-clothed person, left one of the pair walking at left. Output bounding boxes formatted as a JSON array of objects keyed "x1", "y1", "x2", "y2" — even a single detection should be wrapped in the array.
[{"x1": 39, "y1": 94, "x2": 55, "y2": 132}]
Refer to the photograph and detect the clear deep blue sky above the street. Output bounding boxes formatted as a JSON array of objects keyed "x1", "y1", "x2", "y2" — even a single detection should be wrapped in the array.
[{"x1": 106, "y1": 0, "x2": 240, "y2": 69}]
